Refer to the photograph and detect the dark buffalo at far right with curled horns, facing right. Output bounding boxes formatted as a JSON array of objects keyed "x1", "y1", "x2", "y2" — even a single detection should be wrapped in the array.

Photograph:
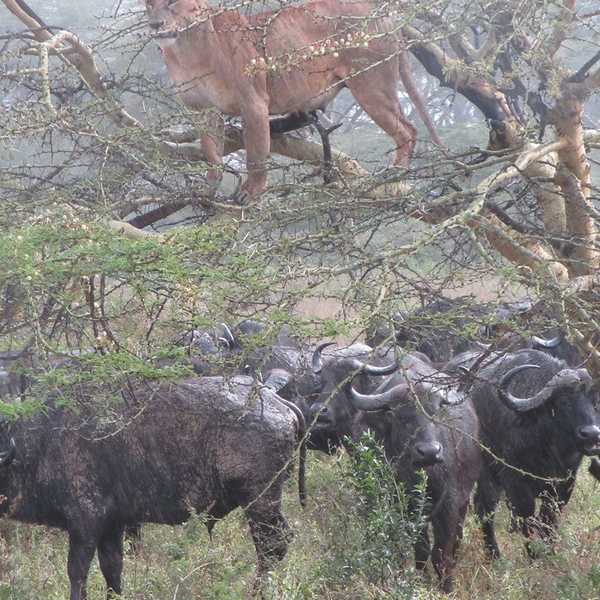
[{"x1": 471, "y1": 350, "x2": 600, "y2": 557}]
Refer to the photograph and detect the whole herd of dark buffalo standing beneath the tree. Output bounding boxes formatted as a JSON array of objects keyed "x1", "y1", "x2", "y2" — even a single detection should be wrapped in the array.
[{"x1": 0, "y1": 299, "x2": 600, "y2": 600}]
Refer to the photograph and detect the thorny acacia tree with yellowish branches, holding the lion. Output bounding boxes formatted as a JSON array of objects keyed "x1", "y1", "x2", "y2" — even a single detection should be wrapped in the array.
[{"x1": 0, "y1": 0, "x2": 600, "y2": 378}]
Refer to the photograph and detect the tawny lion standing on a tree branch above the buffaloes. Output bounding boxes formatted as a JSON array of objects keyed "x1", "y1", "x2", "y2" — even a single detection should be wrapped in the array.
[{"x1": 145, "y1": 0, "x2": 441, "y2": 204}]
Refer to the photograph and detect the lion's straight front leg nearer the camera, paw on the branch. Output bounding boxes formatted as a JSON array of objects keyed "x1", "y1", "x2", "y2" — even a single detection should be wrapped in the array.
[{"x1": 237, "y1": 96, "x2": 271, "y2": 204}]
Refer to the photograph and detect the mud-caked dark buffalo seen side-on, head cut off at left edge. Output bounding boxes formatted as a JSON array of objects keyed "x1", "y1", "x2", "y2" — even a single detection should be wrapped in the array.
[{"x1": 0, "y1": 376, "x2": 303, "y2": 600}]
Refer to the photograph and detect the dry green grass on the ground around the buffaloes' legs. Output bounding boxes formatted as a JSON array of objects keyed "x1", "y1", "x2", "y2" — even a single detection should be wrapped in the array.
[{"x1": 0, "y1": 454, "x2": 600, "y2": 600}]
